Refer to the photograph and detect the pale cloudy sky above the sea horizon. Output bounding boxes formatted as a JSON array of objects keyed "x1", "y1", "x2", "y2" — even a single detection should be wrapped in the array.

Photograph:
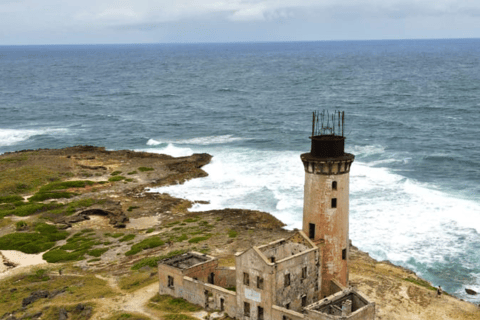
[{"x1": 0, "y1": 0, "x2": 480, "y2": 45}]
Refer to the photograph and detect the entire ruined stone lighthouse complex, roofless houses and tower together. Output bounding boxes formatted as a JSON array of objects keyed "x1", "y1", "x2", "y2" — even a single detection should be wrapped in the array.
[{"x1": 158, "y1": 112, "x2": 375, "y2": 320}]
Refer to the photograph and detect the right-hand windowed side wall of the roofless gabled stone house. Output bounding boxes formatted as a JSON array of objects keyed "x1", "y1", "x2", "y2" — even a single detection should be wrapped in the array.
[{"x1": 273, "y1": 248, "x2": 320, "y2": 312}]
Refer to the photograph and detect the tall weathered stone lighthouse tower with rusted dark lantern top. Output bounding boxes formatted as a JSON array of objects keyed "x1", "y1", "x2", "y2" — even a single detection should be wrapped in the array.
[{"x1": 300, "y1": 111, "x2": 355, "y2": 299}]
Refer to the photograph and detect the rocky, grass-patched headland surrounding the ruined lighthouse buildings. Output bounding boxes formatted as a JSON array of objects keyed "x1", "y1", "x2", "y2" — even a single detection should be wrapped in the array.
[{"x1": 0, "y1": 146, "x2": 480, "y2": 320}]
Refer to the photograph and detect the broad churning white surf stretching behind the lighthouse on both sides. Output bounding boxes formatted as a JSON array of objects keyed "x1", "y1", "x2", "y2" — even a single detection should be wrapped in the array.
[{"x1": 146, "y1": 145, "x2": 480, "y2": 300}]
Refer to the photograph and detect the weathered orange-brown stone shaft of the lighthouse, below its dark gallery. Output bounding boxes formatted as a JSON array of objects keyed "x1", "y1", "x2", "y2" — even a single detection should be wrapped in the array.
[{"x1": 303, "y1": 168, "x2": 349, "y2": 298}]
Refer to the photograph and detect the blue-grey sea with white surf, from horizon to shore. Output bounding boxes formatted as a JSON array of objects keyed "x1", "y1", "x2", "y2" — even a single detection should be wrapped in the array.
[{"x1": 0, "y1": 39, "x2": 480, "y2": 303}]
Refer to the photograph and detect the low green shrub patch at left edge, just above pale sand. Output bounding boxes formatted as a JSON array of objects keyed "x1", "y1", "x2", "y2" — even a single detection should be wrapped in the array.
[{"x1": 0, "y1": 223, "x2": 68, "y2": 253}]
